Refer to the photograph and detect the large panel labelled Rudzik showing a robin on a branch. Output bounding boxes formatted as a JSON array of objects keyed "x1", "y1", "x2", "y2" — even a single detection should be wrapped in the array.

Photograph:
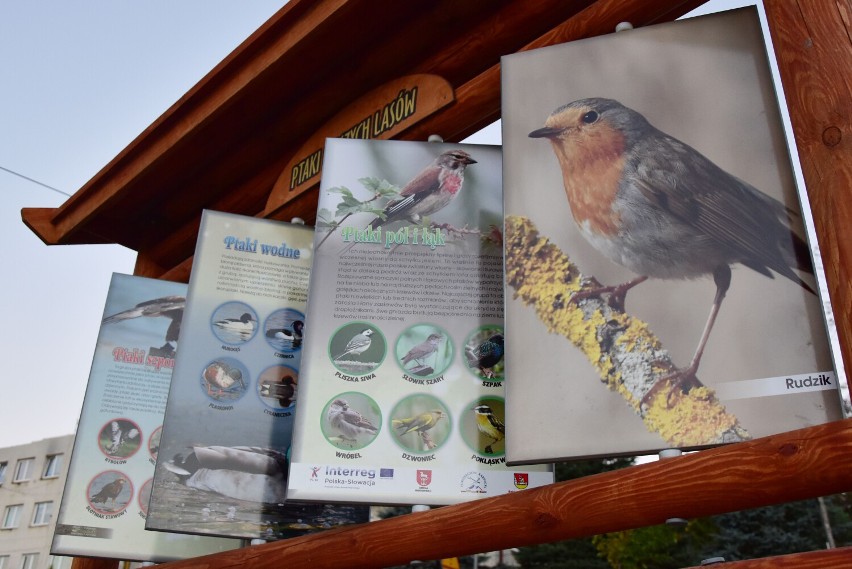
[{"x1": 502, "y1": 8, "x2": 845, "y2": 463}]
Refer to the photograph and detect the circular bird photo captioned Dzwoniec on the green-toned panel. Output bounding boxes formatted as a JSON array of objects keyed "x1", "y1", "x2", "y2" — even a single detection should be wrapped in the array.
[{"x1": 390, "y1": 393, "x2": 452, "y2": 454}]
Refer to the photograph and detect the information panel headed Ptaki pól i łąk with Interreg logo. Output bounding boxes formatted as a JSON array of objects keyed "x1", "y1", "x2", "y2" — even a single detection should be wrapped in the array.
[{"x1": 288, "y1": 139, "x2": 553, "y2": 505}]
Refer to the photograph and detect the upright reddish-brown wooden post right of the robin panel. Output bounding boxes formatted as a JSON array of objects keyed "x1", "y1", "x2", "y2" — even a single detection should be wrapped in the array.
[{"x1": 764, "y1": 0, "x2": 852, "y2": 382}]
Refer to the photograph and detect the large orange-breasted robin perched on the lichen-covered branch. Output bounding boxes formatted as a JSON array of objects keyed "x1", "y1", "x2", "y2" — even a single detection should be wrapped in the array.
[{"x1": 529, "y1": 98, "x2": 814, "y2": 403}]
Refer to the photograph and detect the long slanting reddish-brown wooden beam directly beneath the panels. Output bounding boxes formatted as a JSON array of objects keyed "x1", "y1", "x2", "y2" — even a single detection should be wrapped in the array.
[{"x1": 153, "y1": 419, "x2": 852, "y2": 569}]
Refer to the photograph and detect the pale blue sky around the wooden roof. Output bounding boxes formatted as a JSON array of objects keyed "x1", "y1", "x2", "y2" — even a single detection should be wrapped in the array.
[{"x1": 0, "y1": 0, "x2": 749, "y2": 448}]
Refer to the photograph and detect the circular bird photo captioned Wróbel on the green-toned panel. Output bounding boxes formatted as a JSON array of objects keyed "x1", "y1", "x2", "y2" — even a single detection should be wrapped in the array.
[{"x1": 320, "y1": 391, "x2": 382, "y2": 450}]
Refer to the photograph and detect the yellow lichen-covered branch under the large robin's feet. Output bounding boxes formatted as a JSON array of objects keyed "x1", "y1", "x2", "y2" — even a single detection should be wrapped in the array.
[{"x1": 504, "y1": 216, "x2": 751, "y2": 448}]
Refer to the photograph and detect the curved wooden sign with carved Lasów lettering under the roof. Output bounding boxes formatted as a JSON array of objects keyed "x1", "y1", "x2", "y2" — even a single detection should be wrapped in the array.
[{"x1": 266, "y1": 74, "x2": 454, "y2": 212}]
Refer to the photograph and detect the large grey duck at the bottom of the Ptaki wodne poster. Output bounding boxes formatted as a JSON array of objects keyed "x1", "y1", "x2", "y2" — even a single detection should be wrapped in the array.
[{"x1": 164, "y1": 446, "x2": 287, "y2": 504}]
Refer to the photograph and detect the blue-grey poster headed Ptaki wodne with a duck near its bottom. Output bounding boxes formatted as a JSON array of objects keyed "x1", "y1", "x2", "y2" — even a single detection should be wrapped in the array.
[{"x1": 146, "y1": 211, "x2": 369, "y2": 540}]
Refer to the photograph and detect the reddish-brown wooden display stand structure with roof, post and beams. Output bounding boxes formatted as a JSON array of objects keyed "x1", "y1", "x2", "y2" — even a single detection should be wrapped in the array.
[{"x1": 22, "y1": 0, "x2": 852, "y2": 568}]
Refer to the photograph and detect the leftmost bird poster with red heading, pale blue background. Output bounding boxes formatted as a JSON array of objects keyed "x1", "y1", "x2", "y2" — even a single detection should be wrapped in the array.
[{"x1": 51, "y1": 274, "x2": 240, "y2": 562}]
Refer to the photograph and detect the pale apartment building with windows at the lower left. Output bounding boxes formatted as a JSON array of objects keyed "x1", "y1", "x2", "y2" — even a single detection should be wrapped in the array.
[{"x1": 0, "y1": 435, "x2": 74, "y2": 569}]
